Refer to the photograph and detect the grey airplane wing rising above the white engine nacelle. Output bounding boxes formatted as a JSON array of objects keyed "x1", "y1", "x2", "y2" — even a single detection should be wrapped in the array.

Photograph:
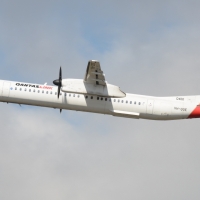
[{"x1": 84, "y1": 60, "x2": 106, "y2": 86}]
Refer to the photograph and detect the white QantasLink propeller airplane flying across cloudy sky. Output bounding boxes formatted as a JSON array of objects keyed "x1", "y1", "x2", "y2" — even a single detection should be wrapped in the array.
[{"x1": 0, "y1": 60, "x2": 200, "y2": 120}]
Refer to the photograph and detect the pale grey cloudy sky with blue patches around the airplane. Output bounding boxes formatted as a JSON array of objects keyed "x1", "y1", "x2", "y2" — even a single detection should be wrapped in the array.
[{"x1": 0, "y1": 0, "x2": 200, "y2": 200}]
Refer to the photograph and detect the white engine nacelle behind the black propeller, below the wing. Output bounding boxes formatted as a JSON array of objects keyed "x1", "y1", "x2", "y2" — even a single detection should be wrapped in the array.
[{"x1": 61, "y1": 79, "x2": 126, "y2": 98}]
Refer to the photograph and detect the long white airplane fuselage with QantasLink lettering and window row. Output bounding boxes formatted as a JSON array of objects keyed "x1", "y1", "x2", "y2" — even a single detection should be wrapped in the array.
[{"x1": 0, "y1": 80, "x2": 200, "y2": 120}]
